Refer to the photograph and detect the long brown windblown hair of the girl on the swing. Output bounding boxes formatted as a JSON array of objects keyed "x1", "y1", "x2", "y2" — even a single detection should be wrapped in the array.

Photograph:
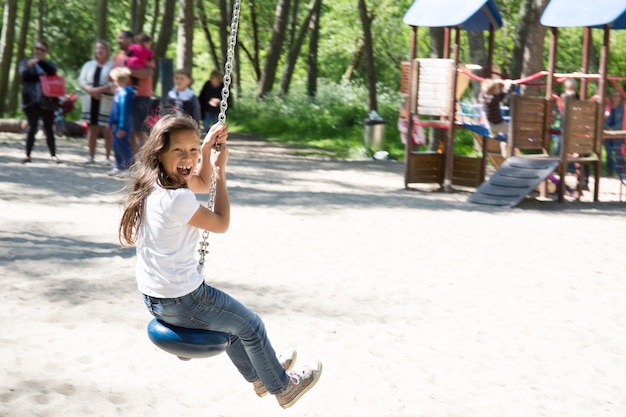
[{"x1": 118, "y1": 112, "x2": 200, "y2": 247}]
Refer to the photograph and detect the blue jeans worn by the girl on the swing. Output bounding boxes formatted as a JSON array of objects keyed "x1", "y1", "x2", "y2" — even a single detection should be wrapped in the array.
[{"x1": 144, "y1": 284, "x2": 289, "y2": 395}]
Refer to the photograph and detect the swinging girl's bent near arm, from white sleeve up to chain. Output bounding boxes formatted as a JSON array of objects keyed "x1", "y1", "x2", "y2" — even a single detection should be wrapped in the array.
[{"x1": 189, "y1": 142, "x2": 230, "y2": 233}]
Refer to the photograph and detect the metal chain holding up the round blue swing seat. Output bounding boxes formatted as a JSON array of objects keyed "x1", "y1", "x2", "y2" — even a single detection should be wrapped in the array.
[{"x1": 198, "y1": 0, "x2": 241, "y2": 274}]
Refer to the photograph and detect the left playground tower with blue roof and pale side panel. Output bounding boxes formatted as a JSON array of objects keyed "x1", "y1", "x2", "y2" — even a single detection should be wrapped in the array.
[{"x1": 401, "y1": 0, "x2": 502, "y2": 191}]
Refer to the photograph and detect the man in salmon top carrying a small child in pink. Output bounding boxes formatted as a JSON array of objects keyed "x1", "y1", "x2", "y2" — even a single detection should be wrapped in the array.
[{"x1": 113, "y1": 31, "x2": 155, "y2": 154}]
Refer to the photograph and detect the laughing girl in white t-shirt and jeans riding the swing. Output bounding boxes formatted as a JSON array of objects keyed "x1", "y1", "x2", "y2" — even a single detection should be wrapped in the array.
[{"x1": 119, "y1": 113, "x2": 322, "y2": 408}]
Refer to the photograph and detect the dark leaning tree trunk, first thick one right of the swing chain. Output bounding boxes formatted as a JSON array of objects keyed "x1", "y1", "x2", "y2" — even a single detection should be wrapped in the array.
[{"x1": 257, "y1": 0, "x2": 291, "y2": 98}]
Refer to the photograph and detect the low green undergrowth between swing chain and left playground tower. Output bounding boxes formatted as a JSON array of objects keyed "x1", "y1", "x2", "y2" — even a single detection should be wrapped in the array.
[{"x1": 229, "y1": 79, "x2": 401, "y2": 158}]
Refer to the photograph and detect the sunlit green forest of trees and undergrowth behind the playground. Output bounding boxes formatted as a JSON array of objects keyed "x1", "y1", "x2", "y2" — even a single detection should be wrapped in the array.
[{"x1": 0, "y1": 0, "x2": 626, "y2": 158}]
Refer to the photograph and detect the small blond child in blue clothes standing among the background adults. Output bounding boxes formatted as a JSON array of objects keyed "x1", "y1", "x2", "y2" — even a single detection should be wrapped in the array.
[{"x1": 107, "y1": 67, "x2": 135, "y2": 177}]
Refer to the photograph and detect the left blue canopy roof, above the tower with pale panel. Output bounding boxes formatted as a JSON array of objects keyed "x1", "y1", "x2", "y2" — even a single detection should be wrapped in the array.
[{"x1": 402, "y1": 0, "x2": 502, "y2": 31}]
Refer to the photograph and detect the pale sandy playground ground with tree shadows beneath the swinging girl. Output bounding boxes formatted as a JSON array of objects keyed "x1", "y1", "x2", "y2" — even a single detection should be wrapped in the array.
[{"x1": 0, "y1": 134, "x2": 626, "y2": 417}]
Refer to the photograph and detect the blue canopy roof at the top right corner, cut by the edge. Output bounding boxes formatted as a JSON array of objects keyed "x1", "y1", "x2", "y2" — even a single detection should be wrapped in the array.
[{"x1": 541, "y1": 0, "x2": 626, "y2": 29}]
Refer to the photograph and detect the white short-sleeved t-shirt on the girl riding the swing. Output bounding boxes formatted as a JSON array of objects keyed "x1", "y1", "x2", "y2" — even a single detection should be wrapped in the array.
[{"x1": 135, "y1": 186, "x2": 204, "y2": 298}]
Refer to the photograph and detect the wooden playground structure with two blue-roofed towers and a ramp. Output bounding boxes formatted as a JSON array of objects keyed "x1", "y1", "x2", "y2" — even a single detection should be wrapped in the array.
[{"x1": 401, "y1": 0, "x2": 626, "y2": 206}]
